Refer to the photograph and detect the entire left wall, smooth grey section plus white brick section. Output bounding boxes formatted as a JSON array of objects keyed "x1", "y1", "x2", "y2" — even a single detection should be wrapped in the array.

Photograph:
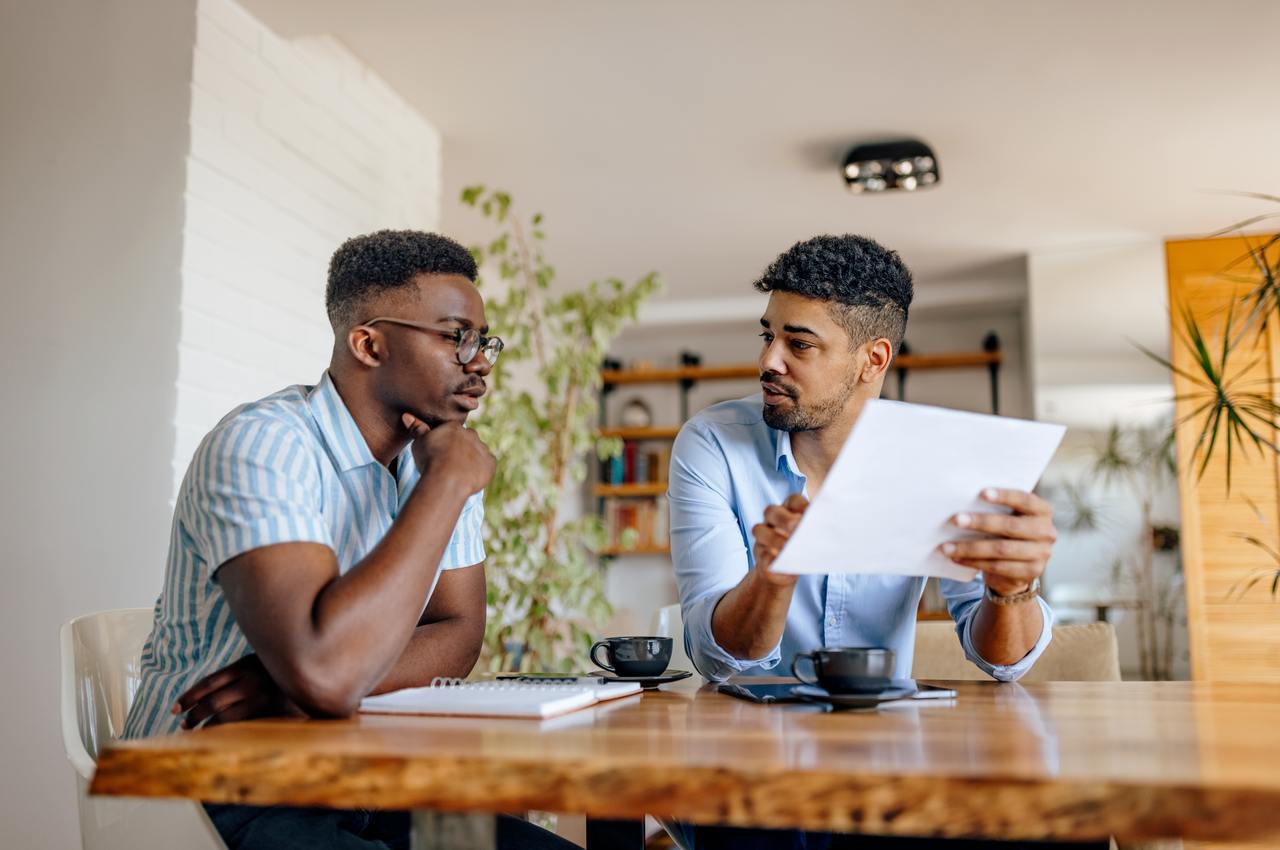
[{"x1": 0, "y1": 0, "x2": 440, "y2": 849}]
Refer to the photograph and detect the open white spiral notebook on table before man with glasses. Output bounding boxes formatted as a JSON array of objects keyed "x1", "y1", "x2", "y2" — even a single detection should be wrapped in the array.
[{"x1": 360, "y1": 678, "x2": 640, "y2": 718}]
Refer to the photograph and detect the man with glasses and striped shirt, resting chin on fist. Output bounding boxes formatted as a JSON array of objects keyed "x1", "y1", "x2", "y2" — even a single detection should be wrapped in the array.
[{"x1": 125, "y1": 230, "x2": 571, "y2": 850}]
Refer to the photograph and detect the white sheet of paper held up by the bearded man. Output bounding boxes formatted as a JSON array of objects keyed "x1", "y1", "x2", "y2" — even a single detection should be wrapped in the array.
[{"x1": 773, "y1": 399, "x2": 1066, "y2": 581}]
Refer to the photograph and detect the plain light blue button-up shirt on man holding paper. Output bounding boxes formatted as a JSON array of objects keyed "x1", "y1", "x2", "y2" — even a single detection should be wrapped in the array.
[{"x1": 667, "y1": 396, "x2": 1053, "y2": 681}]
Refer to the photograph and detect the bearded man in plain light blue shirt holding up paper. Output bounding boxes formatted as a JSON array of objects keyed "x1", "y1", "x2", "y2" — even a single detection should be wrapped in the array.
[{"x1": 668, "y1": 236, "x2": 1055, "y2": 850}]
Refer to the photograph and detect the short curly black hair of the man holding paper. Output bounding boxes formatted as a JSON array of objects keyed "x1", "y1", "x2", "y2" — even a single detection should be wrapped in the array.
[{"x1": 755, "y1": 234, "x2": 914, "y2": 355}]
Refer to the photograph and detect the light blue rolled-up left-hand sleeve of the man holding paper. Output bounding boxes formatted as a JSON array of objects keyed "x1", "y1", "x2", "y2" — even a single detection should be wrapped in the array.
[{"x1": 667, "y1": 422, "x2": 782, "y2": 681}]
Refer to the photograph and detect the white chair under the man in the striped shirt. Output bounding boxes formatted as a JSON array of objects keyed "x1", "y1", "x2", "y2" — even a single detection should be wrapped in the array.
[{"x1": 61, "y1": 608, "x2": 227, "y2": 850}]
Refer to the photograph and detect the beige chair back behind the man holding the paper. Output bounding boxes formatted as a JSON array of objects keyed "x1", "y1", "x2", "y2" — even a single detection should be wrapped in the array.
[{"x1": 911, "y1": 621, "x2": 1120, "y2": 682}]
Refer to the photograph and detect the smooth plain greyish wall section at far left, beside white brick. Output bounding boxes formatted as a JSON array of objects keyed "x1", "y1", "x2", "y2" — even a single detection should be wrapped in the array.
[{"x1": 0, "y1": 0, "x2": 196, "y2": 850}]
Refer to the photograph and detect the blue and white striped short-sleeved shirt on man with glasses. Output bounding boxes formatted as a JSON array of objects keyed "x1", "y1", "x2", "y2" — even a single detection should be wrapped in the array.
[{"x1": 124, "y1": 371, "x2": 485, "y2": 737}]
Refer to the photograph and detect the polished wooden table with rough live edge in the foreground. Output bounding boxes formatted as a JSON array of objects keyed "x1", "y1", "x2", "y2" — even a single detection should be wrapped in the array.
[{"x1": 91, "y1": 682, "x2": 1280, "y2": 846}]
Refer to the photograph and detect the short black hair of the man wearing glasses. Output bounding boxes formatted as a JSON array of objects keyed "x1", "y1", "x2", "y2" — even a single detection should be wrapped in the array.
[{"x1": 324, "y1": 230, "x2": 477, "y2": 332}]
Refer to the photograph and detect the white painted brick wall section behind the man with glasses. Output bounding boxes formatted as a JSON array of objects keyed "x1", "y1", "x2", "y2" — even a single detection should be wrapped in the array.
[{"x1": 173, "y1": 0, "x2": 440, "y2": 492}]
